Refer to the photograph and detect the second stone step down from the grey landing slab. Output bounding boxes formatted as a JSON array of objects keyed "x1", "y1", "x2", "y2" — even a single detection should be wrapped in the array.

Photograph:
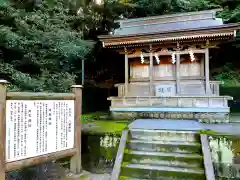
[{"x1": 126, "y1": 139, "x2": 202, "y2": 154}]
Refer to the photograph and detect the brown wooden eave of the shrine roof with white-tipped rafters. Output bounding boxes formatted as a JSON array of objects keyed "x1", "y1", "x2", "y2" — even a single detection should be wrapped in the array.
[{"x1": 99, "y1": 23, "x2": 240, "y2": 47}]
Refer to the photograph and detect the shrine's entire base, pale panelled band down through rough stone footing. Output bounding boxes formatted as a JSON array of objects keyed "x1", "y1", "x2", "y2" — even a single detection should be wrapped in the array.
[{"x1": 109, "y1": 96, "x2": 232, "y2": 123}]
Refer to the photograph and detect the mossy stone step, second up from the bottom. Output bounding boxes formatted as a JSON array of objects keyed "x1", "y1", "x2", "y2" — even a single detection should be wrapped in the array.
[{"x1": 123, "y1": 151, "x2": 203, "y2": 168}]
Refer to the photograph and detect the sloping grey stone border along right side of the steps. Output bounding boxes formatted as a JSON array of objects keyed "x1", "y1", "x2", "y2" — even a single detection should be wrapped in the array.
[{"x1": 200, "y1": 134, "x2": 215, "y2": 180}]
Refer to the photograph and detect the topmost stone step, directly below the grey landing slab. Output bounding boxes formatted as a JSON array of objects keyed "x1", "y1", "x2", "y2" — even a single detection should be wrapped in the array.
[{"x1": 130, "y1": 129, "x2": 200, "y2": 142}]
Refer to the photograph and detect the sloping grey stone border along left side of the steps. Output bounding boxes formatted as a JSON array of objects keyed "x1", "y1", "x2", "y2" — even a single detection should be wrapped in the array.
[{"x1": 111, "y1": 130, "x2": 128, "y2": 180}]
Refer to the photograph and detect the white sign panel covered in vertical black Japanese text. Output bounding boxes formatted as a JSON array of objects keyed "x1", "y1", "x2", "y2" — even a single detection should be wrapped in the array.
[{"x1": 6, "y1": 100, "x2": 74, "y2": 162}]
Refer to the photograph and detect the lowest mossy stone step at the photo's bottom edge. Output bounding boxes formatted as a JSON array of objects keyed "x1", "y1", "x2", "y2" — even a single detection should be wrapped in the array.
[{"x1": 121, "y1": 164, "x2": 205, "y2": 180}]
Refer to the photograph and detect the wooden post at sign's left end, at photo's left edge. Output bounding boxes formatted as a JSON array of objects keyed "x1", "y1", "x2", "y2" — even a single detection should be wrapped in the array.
[{"x1": 0, "y1": 80, "x2": 7, "y2": 180}]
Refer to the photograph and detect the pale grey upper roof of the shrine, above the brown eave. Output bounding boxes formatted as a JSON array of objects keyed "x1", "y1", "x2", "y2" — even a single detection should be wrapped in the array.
[{"x1": 113, "y1": 10, "x2": 223, "y2": 36}]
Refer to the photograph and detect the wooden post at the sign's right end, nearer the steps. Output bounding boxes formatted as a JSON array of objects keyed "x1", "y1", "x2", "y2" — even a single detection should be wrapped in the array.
[{"x1": 70, "y1": 85, "x2": 82, "y2": 174}]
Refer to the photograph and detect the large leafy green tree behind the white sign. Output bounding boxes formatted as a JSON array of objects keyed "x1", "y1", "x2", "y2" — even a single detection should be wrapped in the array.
[{"x1": 0, "y1": 0, "x2": 93, "y2": 92}]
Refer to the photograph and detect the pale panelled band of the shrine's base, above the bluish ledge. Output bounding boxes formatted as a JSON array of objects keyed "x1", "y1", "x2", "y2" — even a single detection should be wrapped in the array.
[{"x1": 108, "y1": 96, "x2": 231, "y2": 108}]
